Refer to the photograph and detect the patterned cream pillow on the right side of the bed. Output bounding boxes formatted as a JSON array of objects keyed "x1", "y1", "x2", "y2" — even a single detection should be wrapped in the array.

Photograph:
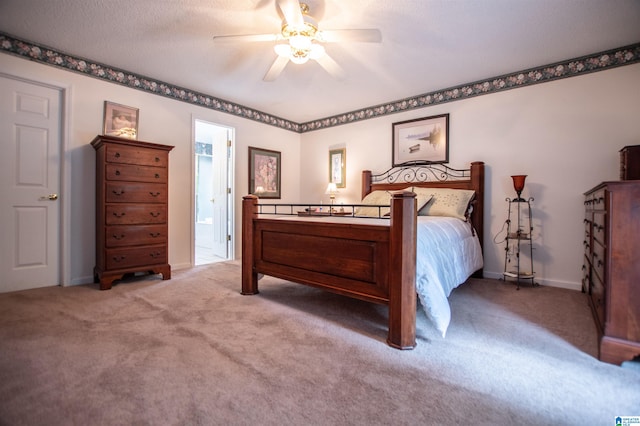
[{"x1": 413, "y1": 187, "x2": 475, "y2": 220}]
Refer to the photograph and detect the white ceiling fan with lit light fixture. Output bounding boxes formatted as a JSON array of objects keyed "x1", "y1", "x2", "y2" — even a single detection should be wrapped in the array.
[{"x1": 213, "y1": 0, "x2": 382, "y2": 81}]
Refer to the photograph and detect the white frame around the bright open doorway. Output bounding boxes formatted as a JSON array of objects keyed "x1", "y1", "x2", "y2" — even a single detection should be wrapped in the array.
[{"x1": 190, "y1": 114, "x2": 236, "y2": 267}]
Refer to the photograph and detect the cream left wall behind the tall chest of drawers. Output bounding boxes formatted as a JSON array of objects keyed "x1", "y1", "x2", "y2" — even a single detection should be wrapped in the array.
[{"x1": 0, "y1": 54, "x2": 300, "y2": 285}]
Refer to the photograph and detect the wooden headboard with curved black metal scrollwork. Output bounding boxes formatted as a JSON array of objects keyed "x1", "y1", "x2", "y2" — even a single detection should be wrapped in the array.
[{"x1": 362, "y1": 161, "x2": 484, "y2": 251}]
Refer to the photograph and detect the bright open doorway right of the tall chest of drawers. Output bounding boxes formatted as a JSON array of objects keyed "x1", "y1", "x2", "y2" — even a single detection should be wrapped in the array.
[{"x1": 194, "y1": 119, "x2": 234, "y2": 265}]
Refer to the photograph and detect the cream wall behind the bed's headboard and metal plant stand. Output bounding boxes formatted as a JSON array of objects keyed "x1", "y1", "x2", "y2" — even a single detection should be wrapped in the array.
[{"x1": 300, "y1": 64, "x2": 640, "y2": 289}]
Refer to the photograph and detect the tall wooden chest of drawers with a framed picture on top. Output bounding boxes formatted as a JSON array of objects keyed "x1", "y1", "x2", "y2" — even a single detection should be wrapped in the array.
[{"x1": 91, "y1": 136, "x2": 173, "y2": 290}]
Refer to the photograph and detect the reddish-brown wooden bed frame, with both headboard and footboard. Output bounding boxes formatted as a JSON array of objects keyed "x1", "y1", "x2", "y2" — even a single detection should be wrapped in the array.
[{"x1": 242, "y1": 162, "x2": 484, "y2": 349}]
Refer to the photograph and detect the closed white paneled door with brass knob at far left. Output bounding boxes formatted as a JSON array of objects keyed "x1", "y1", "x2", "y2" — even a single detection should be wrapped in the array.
[{"x1": 0, "y1": 76, "x2": 62, "y2": 292}]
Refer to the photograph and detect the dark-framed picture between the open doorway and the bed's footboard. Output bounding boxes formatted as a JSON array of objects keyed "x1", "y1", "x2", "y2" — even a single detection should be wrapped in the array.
[{"x1": 249, "y1": 146, "x2": 282, "y2": 198}]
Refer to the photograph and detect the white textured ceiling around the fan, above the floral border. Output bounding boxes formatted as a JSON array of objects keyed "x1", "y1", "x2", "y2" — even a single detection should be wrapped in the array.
[{"x1": 0, "y1": 0, "x2": 640, "y2": 123}]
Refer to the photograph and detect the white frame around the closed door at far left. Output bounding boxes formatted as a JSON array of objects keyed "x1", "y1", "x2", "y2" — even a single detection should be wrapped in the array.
[{"x1": 0, "y1": 71, "x2": 72, "y2": 287}]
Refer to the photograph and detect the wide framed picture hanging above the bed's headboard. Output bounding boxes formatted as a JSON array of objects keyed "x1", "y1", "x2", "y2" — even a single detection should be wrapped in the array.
[{"x1": 391, "y1": 114, "x2": 449, "y2": 167}]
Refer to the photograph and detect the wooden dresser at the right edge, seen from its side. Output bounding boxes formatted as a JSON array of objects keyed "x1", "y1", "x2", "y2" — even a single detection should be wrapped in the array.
[{"x1": 582, "y1": 181, "x2": 640, "y2": 364}]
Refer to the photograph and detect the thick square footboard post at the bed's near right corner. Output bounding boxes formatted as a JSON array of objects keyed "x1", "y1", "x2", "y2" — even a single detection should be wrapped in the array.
[{"x1": 387, "y1": 191, "x2": 417, "y2": 349}]
